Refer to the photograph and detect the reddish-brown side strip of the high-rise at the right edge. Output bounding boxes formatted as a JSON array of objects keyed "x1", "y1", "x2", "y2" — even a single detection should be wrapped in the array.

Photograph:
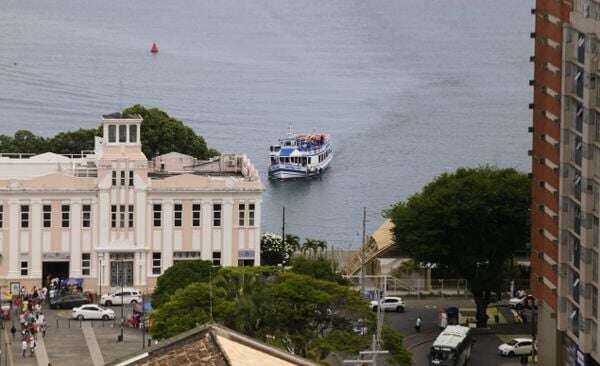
[{"x1": 529, "y1": 0, "x2": 572, "y2": 366}]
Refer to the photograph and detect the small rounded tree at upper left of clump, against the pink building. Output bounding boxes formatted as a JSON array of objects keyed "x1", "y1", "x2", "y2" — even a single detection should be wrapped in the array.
[{"x1": 152, "y1": 261, "x2": 217, "y2": 308}]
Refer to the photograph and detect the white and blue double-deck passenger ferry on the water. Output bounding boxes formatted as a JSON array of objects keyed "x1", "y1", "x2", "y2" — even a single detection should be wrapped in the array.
[{"x1": 269, "y1": 131, "x2": 333, "y2": 179}]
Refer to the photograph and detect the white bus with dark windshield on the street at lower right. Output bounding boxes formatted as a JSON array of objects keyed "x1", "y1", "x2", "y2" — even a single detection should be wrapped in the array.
[{"x1": 429, "y1": 325, "x2": 473, "y2": 366}]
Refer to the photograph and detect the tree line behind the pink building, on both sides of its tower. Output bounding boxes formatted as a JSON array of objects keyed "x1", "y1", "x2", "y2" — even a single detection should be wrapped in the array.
[{"x1": 0, "y1": 105, "x2": 219, "y2": 160}]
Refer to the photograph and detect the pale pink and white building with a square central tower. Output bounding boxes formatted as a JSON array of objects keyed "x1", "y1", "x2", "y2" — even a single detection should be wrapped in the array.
[{"x1": 0, "y1": 114, "x2": 263, "y2": 291}]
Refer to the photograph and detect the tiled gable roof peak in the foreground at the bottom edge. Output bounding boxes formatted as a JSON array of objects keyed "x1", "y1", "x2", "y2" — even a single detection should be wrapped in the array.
[{"x1": 107, "y1": 324, "x2": 317, "y2": 366}]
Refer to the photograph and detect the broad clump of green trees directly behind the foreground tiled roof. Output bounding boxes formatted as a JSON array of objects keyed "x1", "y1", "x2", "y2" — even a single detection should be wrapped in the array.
[{"x1": 150, "y1": 259, "x2": 410, "y2": 366}]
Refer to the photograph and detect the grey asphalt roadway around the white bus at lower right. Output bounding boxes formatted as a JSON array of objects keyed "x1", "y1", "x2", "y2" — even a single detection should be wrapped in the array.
[{"x1": 385, "y1": 298, "x2": 521, "y2": 366}]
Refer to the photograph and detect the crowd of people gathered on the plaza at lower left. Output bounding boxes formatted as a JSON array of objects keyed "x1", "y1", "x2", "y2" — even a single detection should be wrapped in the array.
[{"x1": 10, "y1": 287, "x2": 48, "y2": 357}]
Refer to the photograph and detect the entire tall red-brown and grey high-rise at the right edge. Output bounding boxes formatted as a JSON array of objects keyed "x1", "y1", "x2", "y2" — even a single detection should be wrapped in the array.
[{"x1": 531, "y1": 0, "x2": 600, "y2": 366}]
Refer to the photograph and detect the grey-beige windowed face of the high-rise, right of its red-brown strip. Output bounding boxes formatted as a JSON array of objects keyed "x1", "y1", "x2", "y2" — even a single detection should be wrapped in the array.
[{"x1": 557, "y1": 0, "x2": 600, "y2": 365}]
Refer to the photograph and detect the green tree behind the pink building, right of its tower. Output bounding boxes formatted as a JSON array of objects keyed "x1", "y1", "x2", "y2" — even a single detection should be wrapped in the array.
[{"x1": 123, "y1": 104, "x2": 219, "y2": 160}]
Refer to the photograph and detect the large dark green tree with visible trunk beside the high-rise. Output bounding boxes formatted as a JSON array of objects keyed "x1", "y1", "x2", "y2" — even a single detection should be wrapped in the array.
[{"x1": 388, "y1": 167, "x2": 531, "y2": 327}]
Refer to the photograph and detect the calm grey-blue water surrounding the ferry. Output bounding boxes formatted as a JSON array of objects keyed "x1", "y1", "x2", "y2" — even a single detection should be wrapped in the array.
[{"x1": 0, "y1": 0, "x2": 533, "y2": 247}]
